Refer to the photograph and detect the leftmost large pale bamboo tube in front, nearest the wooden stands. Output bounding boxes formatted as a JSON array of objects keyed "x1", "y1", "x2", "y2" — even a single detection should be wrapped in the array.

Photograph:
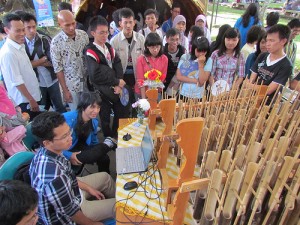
[{"x1": 204, "y1": 169, "x2": 223, "y2": 221}]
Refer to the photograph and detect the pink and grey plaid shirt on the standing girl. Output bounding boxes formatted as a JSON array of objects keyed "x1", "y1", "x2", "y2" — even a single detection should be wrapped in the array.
[{"x1": 211, "y1": 50, "x2": 245, "y2": 88}]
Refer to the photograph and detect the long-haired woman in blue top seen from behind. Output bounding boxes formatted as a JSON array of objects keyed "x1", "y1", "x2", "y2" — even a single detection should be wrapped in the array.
[{"x1": 234, "y1": 3, "x2": 261, "y2": 49}]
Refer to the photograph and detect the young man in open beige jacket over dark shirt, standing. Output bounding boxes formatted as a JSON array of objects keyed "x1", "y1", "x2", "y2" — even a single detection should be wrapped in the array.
[{"x1": 110, "y1": 8, "x2": 145, "y2": 109}]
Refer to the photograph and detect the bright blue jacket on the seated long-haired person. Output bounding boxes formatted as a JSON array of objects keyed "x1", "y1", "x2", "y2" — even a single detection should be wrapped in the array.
[{"x1": 63, "y1": 111, "x2": 99, "y2": 159}]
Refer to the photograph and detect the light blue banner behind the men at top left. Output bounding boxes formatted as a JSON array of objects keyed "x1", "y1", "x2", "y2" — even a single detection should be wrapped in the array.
[{"x1": 33, "y1": 0, "x2": 54, "y2": 27}]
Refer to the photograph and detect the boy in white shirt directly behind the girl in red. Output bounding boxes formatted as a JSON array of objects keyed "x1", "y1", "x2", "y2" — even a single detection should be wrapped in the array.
[{"x1": 139, "y1": 9, "x2": 163, "y2": 39}]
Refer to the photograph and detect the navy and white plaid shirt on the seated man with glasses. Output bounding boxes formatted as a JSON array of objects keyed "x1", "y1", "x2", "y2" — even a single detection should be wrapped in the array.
[{"x1": 29, "y1": 148, "x2": 81, "y2": 225}]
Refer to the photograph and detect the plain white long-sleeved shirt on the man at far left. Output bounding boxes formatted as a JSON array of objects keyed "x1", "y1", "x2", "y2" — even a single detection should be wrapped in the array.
[{"x1": 0, "y1": 38, "x2": 41, "y2": 105}]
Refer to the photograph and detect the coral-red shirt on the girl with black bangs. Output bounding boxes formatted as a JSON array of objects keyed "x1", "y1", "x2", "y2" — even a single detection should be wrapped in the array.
[{"x1": 134, "y1": 55, "x2": 168, "y2": 94}]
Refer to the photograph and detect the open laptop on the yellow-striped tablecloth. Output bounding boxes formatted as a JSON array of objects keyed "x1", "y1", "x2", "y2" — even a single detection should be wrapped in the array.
[{"x1": 116, "y1": 126, "x2": 154, "y2": 174}]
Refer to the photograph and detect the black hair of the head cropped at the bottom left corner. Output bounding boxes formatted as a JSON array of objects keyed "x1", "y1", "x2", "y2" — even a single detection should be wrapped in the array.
[{"x1": 0, "y1": 180, "x2": 38, "y2": 225}]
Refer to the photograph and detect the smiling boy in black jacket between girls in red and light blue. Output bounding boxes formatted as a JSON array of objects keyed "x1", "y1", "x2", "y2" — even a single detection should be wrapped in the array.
[{"x1": 163, "y1": 28, "x2": 185, "y2": 96}]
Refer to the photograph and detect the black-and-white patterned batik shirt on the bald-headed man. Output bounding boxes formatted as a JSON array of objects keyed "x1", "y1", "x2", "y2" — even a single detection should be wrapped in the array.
[{"x1": 51, "y1": 30, "x2": 89, "y2": 92}]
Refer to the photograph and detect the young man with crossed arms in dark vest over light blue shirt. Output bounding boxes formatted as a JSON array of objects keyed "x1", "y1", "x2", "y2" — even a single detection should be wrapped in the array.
[{"x1": 22, "y1": 13, "x2": 66, "y2": 113}]
